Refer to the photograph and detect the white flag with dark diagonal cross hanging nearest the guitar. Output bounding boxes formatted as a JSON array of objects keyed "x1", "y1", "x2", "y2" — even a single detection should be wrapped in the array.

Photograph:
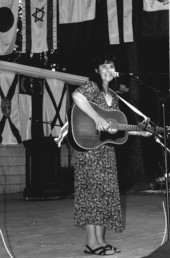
[{"x1": 43, "y1": 79, "x2": 67, "y2": 137}]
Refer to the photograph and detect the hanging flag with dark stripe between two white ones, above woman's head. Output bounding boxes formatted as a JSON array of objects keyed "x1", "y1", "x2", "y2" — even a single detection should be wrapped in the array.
[{"x1": 107, "y1": 0, "x2": 140, "y2": 44}]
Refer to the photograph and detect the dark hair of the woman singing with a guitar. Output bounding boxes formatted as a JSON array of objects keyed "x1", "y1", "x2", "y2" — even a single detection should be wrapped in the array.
[{"x1": 90, "y1": 51, "x2": 116, "y2": 90}]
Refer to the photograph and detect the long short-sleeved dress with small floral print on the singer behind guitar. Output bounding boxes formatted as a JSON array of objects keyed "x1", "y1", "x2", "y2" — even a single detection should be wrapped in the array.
[{"x1": 74, "y1": 82, "x2": 122, "y2": 232}]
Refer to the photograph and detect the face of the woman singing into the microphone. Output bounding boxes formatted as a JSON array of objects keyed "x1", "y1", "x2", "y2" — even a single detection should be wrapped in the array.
[{"x1": 98, "y1": 62, "x2": 116, "y2": 82}]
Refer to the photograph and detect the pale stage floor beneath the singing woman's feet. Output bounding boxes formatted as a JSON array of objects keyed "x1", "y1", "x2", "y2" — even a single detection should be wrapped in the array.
[{"x1": 0, "y1": 193, "x2": 168, "y2": 258}]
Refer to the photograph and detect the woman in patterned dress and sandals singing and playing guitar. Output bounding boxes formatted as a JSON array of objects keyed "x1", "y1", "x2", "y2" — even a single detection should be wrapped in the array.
[{"x1": 72, "y1": 53, "x2": 122, "y2": 255}]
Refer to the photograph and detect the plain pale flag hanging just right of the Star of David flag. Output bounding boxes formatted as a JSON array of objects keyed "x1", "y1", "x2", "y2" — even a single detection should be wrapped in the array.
[{"x1": 59, "y1": 0, "x2": 96, "y2": 24}]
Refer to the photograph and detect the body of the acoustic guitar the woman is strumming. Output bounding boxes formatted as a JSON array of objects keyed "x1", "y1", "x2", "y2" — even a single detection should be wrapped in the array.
[{"x1": 68, "y1": 102, "x2": 128, "y2": 150}]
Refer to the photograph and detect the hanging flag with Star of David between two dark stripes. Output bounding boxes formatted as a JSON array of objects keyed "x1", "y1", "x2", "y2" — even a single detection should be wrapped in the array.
[{"x1": 22, "y1": 0, "x2": 57, "y2": 53}]
